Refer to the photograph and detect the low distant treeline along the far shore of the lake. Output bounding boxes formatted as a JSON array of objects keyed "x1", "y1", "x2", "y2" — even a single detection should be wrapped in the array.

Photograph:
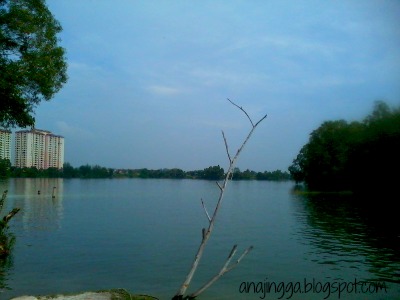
[{"x1": 0, "y1": 162, "x2": 291, "y2": 180}]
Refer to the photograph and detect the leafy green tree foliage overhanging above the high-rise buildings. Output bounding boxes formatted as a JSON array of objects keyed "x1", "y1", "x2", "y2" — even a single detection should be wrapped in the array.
[{"x1": 0, "y1": 0, "x2": 67, "y2": 127}]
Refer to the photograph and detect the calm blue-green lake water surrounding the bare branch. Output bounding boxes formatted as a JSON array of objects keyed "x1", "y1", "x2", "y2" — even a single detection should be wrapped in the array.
[{"x1": 0, "y1": 179, "x2": 400, "y2": 299}]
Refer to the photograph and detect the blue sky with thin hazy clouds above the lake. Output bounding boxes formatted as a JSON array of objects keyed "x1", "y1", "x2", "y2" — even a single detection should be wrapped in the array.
[{"x1": 25, "y1": 0, "x2": 400, "y2": 171}]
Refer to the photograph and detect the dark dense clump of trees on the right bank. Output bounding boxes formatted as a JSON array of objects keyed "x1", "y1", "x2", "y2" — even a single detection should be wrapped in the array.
[{"x1": 289, "y1": 101, "x2": 400, "y2": 194}]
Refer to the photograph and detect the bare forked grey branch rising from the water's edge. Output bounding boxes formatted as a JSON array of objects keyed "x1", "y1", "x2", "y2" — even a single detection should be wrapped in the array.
[{"x1": 172, "y1": 99, "x2": 267, "y2": 300}]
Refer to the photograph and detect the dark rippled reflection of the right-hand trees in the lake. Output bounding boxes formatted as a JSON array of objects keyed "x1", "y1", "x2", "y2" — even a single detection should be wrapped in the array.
[{"x1": 295, "y1": 194, "x2": 400, "y2": 283}]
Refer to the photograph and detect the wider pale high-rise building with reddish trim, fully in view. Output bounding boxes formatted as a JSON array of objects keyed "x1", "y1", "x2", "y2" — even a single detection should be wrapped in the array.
[{"x1": 15, "y1": 129, "x2": 64, "y2": 169}]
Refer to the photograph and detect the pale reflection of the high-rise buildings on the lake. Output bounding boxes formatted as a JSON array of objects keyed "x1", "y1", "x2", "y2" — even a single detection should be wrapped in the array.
[{"x1": 0, "y1": 178, "x2": 64, "y2": 231}]
